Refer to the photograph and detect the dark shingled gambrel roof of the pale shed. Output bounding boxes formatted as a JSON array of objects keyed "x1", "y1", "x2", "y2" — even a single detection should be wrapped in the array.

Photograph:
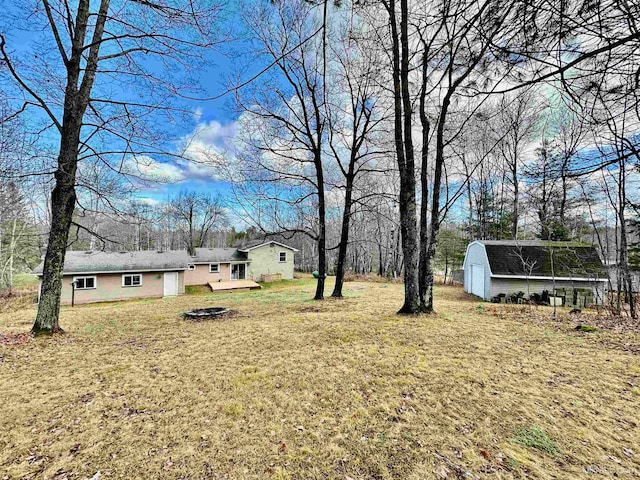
[{"x1": 478, "y1": 240, "x2": 606, "y2": 279}]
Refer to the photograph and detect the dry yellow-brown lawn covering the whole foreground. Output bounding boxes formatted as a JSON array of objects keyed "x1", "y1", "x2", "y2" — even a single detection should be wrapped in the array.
[{"x1": 0, "y1": 280, "x2": 640, "y2": 480}]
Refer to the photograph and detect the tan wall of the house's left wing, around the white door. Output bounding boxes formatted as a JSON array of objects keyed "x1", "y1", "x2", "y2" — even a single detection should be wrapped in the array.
[{"x1": 60, "y1": 271, "x2": 184, "y2": 305}]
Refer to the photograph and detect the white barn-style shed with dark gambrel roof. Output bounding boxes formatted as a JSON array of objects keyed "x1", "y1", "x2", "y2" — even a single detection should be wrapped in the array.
[{"x1": 463, "y1": 240, "x2": 608, "y2": 305}]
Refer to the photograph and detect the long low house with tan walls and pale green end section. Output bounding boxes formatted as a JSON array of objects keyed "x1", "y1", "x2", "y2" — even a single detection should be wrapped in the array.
[{"x1": 33, "y1": 241, "x2": 297, "y2": 304}]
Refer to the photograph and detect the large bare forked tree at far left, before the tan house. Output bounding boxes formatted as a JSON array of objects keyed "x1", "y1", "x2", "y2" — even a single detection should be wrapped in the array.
[{"x1": 0, "y1": 0, "x2": 219, "y2": 334}]
